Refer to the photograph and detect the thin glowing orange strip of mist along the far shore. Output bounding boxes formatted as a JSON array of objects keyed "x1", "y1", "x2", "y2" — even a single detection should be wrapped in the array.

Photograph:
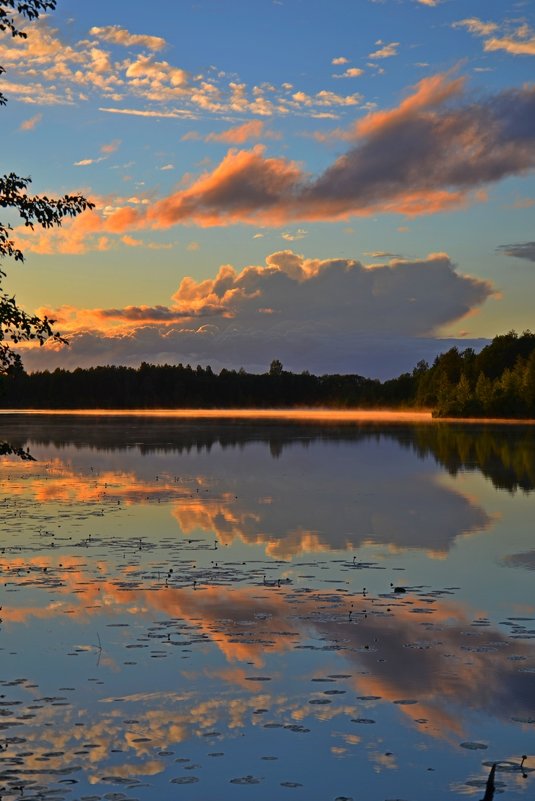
[{"x1": 0, "y1": 409, "x2": 535, "y2": 425}]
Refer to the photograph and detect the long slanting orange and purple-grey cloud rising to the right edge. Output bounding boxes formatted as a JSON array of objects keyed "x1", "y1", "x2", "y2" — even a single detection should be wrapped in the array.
[{"x1": 17, "y1": 73, "x2": 535, "y2": 252}]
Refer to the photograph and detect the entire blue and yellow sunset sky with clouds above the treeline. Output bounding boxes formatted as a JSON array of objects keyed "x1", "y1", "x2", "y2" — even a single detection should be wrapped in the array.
[{"x1": 0, "y1": 0, "x2": 535, "y2": 379}]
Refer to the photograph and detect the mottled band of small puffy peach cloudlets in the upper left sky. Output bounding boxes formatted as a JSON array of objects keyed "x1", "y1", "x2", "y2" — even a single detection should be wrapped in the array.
[{"x1": 0, "y1": 21, "x2": 368, "y2": 119}]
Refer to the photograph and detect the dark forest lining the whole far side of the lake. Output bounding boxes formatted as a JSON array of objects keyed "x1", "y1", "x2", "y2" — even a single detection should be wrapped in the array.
[{"x1": 0, "y1": 331, "x2": 535, "y2": 419}]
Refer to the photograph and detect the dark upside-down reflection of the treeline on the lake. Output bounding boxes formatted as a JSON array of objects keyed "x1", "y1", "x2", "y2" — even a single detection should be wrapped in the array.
[{"x1": 6, "y1": 415, "x2": 535, "y2": 491}]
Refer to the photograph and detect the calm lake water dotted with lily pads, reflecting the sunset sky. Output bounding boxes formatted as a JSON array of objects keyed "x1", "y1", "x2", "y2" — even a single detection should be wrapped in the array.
[{"x1": 0, "y1": 415, "x2": 535, "y2": 801}]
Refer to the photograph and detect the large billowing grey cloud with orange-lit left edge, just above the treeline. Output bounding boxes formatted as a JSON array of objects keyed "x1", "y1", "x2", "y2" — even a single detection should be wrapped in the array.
[{"x1": 25, "y1": 250, "x2": 493, "y2": 377}]
